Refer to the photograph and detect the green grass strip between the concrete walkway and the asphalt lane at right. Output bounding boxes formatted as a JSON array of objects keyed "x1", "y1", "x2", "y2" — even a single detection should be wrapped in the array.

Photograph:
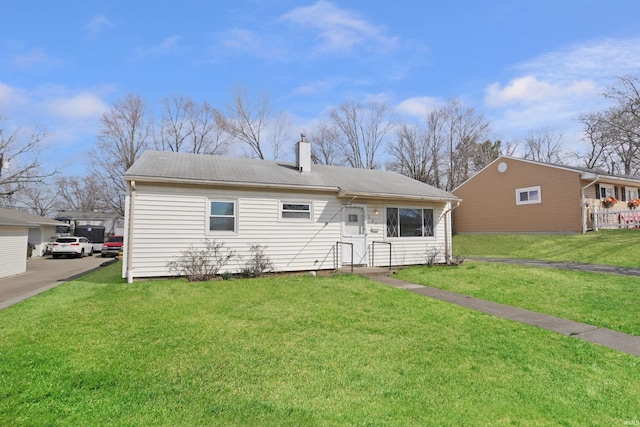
[{"x1": 396, "y1": 260, "x2": 640, "y2": 336}]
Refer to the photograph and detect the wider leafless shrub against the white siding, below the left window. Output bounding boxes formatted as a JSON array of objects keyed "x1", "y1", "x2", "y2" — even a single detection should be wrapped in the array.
[{"x1": 167, "y1": 239, "x2": 235, "y2": 282}]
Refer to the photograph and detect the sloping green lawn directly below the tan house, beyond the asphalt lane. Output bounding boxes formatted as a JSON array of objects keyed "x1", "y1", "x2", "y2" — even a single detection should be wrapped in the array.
[{"x1": 453, "y1": 229, "x2": 640, "y2": 268}]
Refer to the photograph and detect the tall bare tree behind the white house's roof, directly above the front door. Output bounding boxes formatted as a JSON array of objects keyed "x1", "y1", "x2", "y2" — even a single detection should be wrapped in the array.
[{"x1": 330, "y1": 101, "x2": 395, "y2": 169}]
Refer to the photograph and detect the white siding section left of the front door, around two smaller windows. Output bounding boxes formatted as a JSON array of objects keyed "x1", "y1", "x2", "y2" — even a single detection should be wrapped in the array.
[{"x1": 123, "y1": 183, "x2": 341, "y2": 277}]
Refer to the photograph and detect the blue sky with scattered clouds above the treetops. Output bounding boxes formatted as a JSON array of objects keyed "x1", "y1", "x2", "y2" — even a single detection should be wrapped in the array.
[{"x1": 0, "y1": 0, "x2": 640, "y2": 174}]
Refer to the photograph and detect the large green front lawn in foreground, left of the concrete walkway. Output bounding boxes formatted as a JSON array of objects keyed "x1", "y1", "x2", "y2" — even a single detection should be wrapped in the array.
[{"x1": 0, "y1": 263, "x2": 640, "y2": 426}]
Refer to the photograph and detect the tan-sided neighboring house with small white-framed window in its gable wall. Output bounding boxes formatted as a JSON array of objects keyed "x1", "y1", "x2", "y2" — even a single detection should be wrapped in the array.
[{"x1": 453, "y1": 156, "x2": 640, "y2": 233}]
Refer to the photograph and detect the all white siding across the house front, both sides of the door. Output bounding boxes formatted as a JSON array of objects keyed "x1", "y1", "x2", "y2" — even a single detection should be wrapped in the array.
[{"x1": 122, "y1": 186, "x2": 450, "y2": 278}]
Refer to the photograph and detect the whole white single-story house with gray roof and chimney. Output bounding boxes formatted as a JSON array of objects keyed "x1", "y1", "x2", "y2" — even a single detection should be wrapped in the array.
[{"x1": 122, "y1": 141, "x2": 458, "y2": 281}]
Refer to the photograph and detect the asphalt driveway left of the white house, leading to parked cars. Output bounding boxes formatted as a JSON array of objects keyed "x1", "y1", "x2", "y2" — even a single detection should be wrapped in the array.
[{"x1": 0, "y1": 255, "x2": 114, "y2": 310}]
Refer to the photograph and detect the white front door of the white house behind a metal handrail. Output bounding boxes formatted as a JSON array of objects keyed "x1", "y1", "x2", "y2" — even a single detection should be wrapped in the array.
[{"x1": 341, "y1": 205, "x2": 367, "y2": 265}]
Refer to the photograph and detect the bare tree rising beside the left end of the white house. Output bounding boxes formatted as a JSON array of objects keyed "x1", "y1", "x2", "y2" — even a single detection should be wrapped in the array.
[{"x1": 90, "y1": 94, "x2": 152, "y2": 215}]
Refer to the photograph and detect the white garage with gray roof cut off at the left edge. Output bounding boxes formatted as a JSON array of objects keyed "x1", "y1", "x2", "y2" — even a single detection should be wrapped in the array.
[{"x1": 0, "y1": 208, "x2": 63, "y2": 277}]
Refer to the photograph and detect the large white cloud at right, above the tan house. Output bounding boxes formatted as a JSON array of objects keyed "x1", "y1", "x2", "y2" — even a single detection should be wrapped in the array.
[{"x1": 484, "y1": 37, "x2": 640, "y2": 147}]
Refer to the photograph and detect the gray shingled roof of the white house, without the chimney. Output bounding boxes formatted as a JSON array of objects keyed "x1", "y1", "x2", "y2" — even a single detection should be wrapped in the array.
[{"x1": 125, "y1": 151, "x2": 459, "y2": 200}]
